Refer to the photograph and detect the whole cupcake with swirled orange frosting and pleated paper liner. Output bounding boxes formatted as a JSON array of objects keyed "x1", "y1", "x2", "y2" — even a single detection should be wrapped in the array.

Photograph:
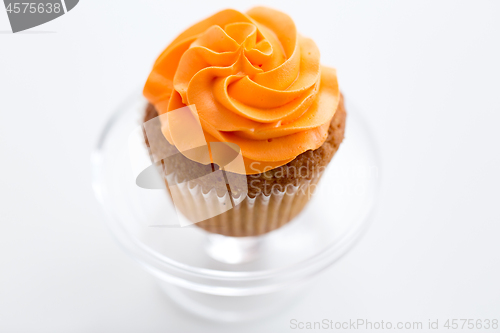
[{"x1": 144, "y1": 7, "x2": 346, "y2": 237}]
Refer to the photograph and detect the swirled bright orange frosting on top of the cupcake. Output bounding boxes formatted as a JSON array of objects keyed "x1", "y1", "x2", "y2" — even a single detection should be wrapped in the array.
[{"x1": 144, "y1": 7, "x2": 340, "y2": 174}]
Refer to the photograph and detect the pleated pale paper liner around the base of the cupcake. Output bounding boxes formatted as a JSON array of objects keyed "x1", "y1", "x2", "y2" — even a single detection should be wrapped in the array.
[{"x1": 162, "y1": 170, "x2": 321, "y2": 237}]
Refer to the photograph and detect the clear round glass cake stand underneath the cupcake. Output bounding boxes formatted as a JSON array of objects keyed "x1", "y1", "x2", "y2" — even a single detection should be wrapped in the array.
[{"x1": 91, "y1": 95, "x2": 380, "y2": 322}]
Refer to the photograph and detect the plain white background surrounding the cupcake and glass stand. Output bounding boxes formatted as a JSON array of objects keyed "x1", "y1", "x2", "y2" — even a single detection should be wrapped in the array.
[{"x1": 0, "y1": 0, "x2": 500, "y2": 332}]
